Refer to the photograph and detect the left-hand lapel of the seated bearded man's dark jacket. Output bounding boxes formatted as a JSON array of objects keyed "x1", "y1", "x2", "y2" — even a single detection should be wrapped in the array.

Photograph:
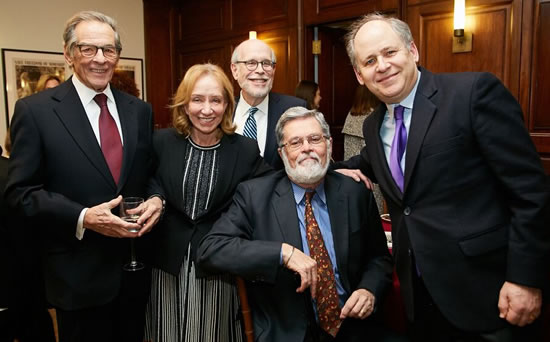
[{"x1": 272, "y1": 176, "x2": 304, "y2": 251}]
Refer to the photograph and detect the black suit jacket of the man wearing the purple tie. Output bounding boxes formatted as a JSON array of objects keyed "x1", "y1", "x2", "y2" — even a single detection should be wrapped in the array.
[{"x1": 336, "y1": 69, "x2": 550, "y2": 331}]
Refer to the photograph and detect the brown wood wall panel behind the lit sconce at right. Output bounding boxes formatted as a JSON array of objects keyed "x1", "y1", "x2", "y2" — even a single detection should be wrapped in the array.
[{"x1": 407, "y1": 0, "x2": 521, "y2": 98}]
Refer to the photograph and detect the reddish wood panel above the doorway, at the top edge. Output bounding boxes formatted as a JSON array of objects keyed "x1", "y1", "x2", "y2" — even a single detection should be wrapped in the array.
[{"x1": 303, "y1": 0, "x2": 400, "y2": 26}]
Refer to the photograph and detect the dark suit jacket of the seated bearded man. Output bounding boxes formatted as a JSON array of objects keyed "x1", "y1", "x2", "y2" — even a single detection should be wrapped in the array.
[{"x1": 198, "y1": 170, "x2": 392, "y2": 341}]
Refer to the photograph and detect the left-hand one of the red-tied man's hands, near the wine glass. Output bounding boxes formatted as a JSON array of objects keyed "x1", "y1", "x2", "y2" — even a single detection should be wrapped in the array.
[{"x1": 84, "y1": 196, "x2": 141, "y2": 238}]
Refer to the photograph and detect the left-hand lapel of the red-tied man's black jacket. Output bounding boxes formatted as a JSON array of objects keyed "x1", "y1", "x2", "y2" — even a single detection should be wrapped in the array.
[{"x1": 52, "y1": 79, "x2": 116, "y2": 189}]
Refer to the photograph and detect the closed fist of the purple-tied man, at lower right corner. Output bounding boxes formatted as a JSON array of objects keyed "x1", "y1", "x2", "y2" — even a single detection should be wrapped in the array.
[{"x1": 498, "y1": 281, "x2": 542, "y2": 327}]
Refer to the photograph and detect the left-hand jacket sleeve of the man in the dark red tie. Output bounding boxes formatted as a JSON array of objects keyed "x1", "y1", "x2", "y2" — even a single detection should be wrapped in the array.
[{"x1": 6, "y1": 100, "x2": 84, "y2": 227}]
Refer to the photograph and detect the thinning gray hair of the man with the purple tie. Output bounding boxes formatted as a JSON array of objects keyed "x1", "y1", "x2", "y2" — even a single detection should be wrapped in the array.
[{"x1": 344, "y1": 12, "x2": 413, "y2": 70}]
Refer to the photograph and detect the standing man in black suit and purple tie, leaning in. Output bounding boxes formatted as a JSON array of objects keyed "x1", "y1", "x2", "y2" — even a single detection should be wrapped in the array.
[{"x1": 336, "y1": 14, "x2": 550, "y2": 342}]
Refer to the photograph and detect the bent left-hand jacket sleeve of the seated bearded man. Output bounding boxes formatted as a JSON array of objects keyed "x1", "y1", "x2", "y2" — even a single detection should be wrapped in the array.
[{"x1": 197, "y1": 184, "x2": 281, "y2": 283}]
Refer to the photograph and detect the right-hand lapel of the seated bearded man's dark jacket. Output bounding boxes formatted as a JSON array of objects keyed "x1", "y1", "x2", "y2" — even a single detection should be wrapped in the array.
[{"x1": 325, "y1": 172, "x2": 350, "y2": 291}]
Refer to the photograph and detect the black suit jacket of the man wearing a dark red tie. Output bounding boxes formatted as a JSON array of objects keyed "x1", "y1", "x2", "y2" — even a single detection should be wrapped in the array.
[{"x1": 6, "y1": 80, "x2": 153, "y2": 310}]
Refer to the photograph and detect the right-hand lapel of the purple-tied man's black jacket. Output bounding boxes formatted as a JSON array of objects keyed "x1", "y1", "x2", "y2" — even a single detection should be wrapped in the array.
[{"x1": 404, "y1": 69, "x2": 437, "y2": 191}]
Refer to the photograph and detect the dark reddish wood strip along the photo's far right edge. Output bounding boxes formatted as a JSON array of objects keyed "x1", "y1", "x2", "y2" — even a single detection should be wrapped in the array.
[{"x1": 528, "y1": 0, "x2": 550, "y2": 174}]
